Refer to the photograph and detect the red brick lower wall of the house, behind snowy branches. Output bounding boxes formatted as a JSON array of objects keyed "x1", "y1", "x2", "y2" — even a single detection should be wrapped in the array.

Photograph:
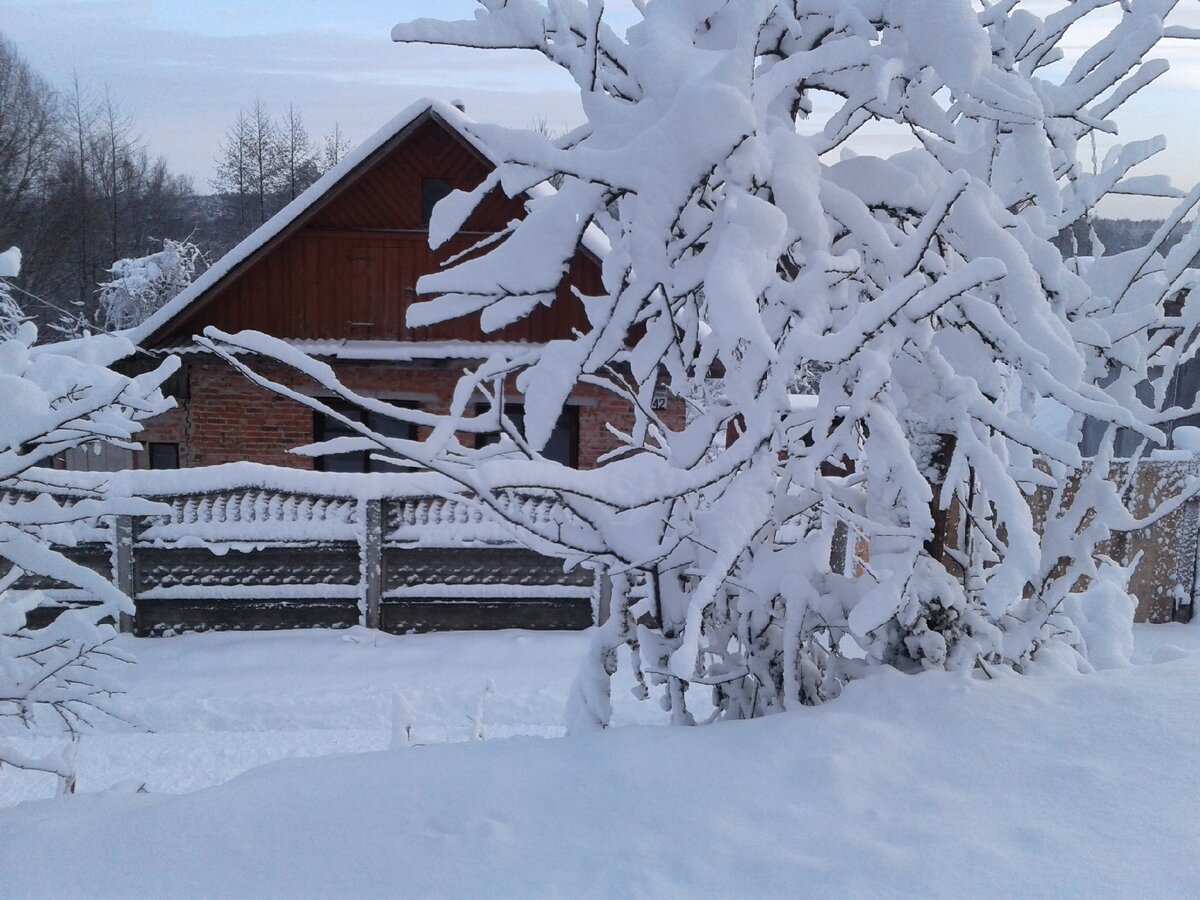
[{"x1": 137, "y1": 356, "x2": 683, "y2": 469}]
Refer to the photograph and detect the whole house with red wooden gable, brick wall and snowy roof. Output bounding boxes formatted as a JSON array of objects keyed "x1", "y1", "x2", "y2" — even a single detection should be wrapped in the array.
[{"x1": 120, "y1": 100, "x2": 628, "y2": 472}]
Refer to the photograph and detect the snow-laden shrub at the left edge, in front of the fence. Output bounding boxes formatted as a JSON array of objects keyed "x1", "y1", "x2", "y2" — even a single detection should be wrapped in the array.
[{"x1": 0, "y1": 248, "x2": 178, "y2": 790}]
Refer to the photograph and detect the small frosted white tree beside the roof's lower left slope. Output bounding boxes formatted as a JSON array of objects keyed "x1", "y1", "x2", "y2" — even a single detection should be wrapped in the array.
[{"x1": 100, "y1": 238, "x2": 205, "y2": 331}]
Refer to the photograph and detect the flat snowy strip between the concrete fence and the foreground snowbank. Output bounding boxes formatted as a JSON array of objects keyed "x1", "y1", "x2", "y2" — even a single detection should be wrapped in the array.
[{"x1": 0, "y1": 628, "x2": 662, "y2": 808}]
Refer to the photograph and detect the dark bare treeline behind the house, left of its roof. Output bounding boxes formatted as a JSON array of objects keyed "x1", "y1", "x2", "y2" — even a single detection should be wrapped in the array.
[{"x1": 0, "y1": 35, "x2": 349, "y2": 337}]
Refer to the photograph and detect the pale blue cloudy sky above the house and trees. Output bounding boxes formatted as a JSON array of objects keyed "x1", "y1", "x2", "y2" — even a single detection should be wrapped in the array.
[{"x1": 0, "y1": 0, "x2": 1200, "y2": 215}]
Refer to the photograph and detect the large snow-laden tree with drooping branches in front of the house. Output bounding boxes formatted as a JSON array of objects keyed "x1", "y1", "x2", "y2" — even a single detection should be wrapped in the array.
[{"x1": 209, "y1": 0, "x2": 1200, "y2": 725}]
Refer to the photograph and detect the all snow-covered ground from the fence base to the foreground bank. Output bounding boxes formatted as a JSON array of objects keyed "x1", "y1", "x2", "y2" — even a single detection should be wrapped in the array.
[{"x1": 0, "y1": 625, "x2": 1200, "y2": 898}]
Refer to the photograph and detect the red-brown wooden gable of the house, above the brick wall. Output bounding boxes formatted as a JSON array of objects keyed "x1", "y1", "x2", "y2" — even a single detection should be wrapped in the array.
[{"x1": 143, "y1": 112, "x2": 600, "y2": 347}]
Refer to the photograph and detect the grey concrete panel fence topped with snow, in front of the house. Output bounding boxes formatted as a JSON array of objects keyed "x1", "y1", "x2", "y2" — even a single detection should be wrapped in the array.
[{"x1": 0, "y1": 463, "x2": 599, "y2": 635}]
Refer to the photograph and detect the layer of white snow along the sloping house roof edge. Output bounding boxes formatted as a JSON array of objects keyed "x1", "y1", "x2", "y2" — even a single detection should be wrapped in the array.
[{"x1": 129, "y1": 97, "x2": 608, "y2": 344}]
